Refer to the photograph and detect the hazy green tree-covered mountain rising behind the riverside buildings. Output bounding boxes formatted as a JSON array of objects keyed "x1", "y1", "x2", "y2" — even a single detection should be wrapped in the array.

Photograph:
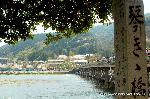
[{"x1": 0, "y1": 14, "x2": 150, "y2": 61}]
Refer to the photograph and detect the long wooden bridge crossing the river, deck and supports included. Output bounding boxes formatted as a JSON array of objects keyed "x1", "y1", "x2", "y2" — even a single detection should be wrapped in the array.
[{"x1": 73, "y1": 63, "x2": 150, "y2": 89}]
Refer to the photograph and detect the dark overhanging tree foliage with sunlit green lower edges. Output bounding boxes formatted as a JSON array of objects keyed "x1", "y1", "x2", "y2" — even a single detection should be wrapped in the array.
[{"x1": 0, "y1": 0, "x2": 112, "y2": 44}]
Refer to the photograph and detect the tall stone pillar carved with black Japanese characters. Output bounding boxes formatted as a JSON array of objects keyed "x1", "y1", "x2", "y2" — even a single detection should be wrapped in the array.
[{"x1": 113, "y1": 0, "x2": 148, "y2": 99}]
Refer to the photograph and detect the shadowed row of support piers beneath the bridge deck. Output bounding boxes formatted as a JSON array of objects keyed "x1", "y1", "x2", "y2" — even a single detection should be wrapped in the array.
[{"x1": 74, "y1": 67, "x2": 114, "y2": 89}]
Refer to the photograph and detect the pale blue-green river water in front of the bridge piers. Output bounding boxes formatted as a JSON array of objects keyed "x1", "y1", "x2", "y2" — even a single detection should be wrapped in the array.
[{"x1": 0, "y1": 74, "x2": 113, "y2": 99}]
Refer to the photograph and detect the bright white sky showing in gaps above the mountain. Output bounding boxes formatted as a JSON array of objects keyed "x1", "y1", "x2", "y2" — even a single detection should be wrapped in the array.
[{"x1": 0, "y1": 0, "x2": 150, "y2": 46}]
